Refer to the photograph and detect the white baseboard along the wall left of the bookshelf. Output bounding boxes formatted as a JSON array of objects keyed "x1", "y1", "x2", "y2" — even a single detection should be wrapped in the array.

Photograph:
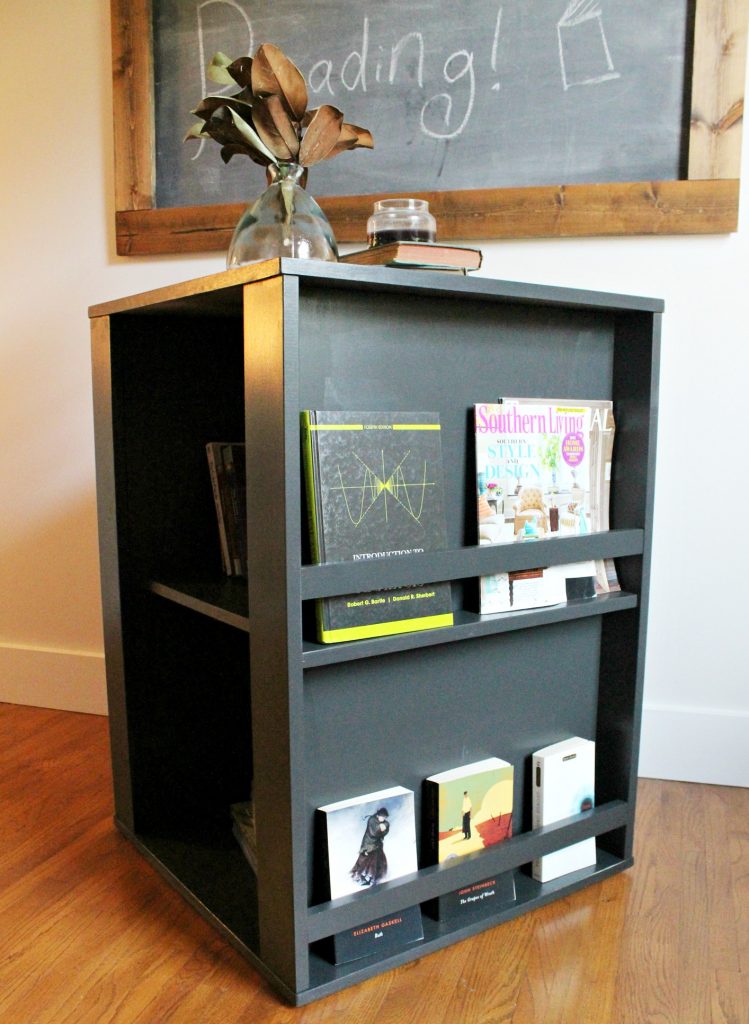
[{"x1": 0, "y1": 644, "x2": 107, "y2": 715}]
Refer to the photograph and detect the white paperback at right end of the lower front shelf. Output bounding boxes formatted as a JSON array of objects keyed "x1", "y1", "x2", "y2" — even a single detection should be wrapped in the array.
[{"x1": 532, "y1": 736, "x2": 595, "y2": 882}]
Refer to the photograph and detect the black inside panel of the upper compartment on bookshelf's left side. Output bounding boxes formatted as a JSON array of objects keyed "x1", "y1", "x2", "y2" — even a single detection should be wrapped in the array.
[{"x1": 112, "y1": 315, "x2": 244, "y2": 583}]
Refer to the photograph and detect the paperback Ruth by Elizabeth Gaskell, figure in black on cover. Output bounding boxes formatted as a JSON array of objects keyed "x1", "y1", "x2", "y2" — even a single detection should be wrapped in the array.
[{"x1": 318, "y1": 785, "x2": 424, "y2": 964}]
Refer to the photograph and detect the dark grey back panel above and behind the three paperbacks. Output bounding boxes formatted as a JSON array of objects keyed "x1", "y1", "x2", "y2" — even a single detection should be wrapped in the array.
[{"x1": 304, "y1": 620, "x2": 600, "y2": 901}]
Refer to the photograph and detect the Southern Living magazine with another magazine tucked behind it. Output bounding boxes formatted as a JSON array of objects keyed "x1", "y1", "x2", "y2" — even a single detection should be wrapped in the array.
[{"x1": 474, "y1": 398, "x2": 619, "y2": 614}]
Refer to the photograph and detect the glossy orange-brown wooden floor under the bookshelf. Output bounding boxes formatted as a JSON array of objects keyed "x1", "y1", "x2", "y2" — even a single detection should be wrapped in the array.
[{"x1": 0, "y1": 705, "x2": 749, "y2": 1024}]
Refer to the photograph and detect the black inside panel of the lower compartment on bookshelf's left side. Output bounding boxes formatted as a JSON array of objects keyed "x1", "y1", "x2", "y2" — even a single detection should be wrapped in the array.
[{"x1": 123, "y1": 594, "x2": 252, "y2": 837}]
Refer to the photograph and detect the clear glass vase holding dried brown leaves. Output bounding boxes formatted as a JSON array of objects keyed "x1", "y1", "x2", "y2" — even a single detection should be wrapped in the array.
[{"x1": 226, "y1": 164, "x2": 338, "y2": 268}]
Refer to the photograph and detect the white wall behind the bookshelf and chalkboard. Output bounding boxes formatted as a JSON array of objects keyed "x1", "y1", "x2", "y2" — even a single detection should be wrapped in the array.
[{"x1": 0, "y1": 0, "x2": 749, "y2": 784}]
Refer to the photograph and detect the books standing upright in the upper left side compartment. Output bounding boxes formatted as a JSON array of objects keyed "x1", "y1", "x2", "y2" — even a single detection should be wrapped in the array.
[{"x1": 206, "y1": 441, "x2": 247, "y2": 577}]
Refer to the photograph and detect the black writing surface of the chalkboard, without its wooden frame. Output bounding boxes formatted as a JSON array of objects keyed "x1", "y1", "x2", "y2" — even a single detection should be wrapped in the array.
[{"x1": 153, "y1": 0, "x2": 695, "y2": 207}]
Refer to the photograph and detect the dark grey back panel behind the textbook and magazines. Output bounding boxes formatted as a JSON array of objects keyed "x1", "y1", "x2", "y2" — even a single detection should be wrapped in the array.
[{"x1": 299, "y1": 283, "x2": 615, "y2": 547}]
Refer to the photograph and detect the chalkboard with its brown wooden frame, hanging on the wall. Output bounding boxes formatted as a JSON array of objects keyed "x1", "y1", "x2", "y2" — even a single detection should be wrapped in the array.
[{"x1": 110, "y1": 0, "x2": 749, "y2": 255}]
